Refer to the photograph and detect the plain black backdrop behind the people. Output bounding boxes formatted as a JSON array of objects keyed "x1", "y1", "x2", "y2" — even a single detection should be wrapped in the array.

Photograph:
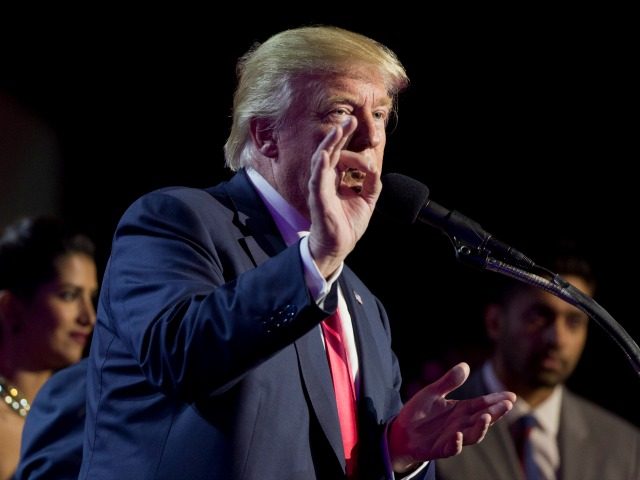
[{"x1": 0, "y1": 10, "x2": 640, "y2": 425}]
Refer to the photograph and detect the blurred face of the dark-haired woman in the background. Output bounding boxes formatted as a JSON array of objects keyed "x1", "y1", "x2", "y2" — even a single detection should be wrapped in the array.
[{"x1": 14, "y1": 253, "x2": 98, "y2": 369}]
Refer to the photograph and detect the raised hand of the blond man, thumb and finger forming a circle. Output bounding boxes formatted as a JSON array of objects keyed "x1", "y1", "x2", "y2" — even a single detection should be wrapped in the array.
[{"x1": 308, "y1": 117, "x2": 382, "y2": 276}]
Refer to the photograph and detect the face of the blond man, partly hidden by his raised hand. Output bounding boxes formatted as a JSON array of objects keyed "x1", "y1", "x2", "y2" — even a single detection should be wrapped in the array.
[{"x1": 270, "y1": 69, "x2": 392, "y2": 217}]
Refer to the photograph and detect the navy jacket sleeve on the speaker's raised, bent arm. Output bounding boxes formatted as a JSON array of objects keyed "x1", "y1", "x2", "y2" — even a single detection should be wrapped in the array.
[{"x1": 101, "y1": 191, "x2": 327, "y2": 400}]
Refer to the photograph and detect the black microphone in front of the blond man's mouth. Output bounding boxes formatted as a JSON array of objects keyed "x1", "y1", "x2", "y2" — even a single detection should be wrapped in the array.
[{"x1": 376, "y1": 173, "x2": 536, "y2": 268}]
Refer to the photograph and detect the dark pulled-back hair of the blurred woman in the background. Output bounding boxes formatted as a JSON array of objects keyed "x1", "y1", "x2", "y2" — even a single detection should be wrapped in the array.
[{"x1": 0, "y1": 216, "x2": 95, "y2": 298}]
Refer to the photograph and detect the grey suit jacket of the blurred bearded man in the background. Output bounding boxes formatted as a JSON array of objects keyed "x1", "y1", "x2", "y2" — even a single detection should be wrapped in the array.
[{"x1": 437, "y1": 369, "x2": 640, "y2": 480}]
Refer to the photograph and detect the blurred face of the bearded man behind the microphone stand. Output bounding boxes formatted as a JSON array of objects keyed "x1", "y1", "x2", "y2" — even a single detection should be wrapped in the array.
[{"x1": 487, "y1": 275, "x2": 593, "y2": 389}]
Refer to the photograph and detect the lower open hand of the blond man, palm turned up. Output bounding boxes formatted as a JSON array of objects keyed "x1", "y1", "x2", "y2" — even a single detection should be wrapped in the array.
[{"x1": 388, "y1": 363, "x2": 516, "y2": 472}]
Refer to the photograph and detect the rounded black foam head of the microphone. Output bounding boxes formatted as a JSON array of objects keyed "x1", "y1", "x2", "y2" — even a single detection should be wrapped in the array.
[{"x1": 376, "y1": 173, "x2": 429, "y2": 224}]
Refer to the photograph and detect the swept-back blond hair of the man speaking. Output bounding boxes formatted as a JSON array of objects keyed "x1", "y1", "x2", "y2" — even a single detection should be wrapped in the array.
[{"x1": 224, "y1": 26, "x2": 409, "y2": 170}]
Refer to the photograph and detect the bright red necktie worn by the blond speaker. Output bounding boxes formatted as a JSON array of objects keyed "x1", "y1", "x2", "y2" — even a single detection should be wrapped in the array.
[{"x1": 321, "y1": 310, "x2": 358, "y2": 477}]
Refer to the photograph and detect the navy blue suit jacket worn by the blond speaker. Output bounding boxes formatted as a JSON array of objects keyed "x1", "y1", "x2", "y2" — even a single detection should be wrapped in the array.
[{"x1": 79, "y1": 172, "x2": 433, "y2": 480}]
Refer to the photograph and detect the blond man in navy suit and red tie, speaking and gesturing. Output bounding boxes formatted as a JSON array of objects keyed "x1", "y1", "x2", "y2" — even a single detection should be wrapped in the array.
[{"x1": 79, "y1": 27, "x2": 515, "y2": 480}]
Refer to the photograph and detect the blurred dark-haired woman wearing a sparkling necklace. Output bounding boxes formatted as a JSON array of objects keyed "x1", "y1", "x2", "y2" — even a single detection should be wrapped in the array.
[{"x1": 0, "y1": 217, "x2": 98, "y2": 480}]
